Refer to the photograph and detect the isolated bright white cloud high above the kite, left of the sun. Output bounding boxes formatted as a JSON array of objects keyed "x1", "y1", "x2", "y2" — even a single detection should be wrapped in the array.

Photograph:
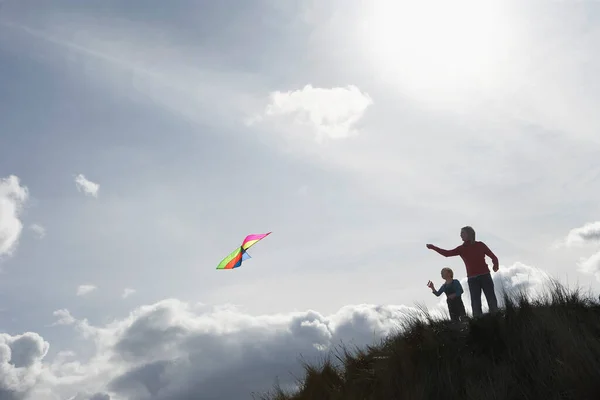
[{"x1": 247, "y1": 85, "x2": 373, "y2": 142}]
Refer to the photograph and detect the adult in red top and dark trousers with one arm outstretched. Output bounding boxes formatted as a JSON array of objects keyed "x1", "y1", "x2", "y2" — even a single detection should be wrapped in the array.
[{"x1": 427, "y1": 226, "x2": 499, "y2": 317}]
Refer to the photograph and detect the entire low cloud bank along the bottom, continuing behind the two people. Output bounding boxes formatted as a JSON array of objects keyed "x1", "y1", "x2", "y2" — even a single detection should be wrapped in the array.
[{"x1": 0, "y1": 263, "x2": 546, "y2": 400}]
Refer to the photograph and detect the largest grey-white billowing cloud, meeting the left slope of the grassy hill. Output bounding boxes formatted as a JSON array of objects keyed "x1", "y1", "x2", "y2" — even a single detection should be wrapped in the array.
[{"x1": 38, "y1": 299, "x2": 417, "y2": 400}]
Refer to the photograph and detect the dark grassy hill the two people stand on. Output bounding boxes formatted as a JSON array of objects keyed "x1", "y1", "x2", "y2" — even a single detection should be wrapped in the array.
[{"x1": 257, "y1": 283, "x2": 600, "y2": 400}]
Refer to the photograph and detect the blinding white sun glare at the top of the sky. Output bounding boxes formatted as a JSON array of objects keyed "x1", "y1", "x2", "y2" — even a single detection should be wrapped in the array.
[{"x1": 361, "y1": 0, "x2": 510, "y2": 108}]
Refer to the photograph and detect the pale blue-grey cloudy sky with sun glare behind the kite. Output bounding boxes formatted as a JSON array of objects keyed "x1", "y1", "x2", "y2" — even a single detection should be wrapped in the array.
[{"x1": 0, "y1": 0, "x2": 600, "y2": 400}]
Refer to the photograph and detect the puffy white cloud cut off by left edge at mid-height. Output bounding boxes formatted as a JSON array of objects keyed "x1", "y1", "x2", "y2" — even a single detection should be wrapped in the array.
[{"x1": 0, "y1": 175, "x2": 29, "y2": 256}]
